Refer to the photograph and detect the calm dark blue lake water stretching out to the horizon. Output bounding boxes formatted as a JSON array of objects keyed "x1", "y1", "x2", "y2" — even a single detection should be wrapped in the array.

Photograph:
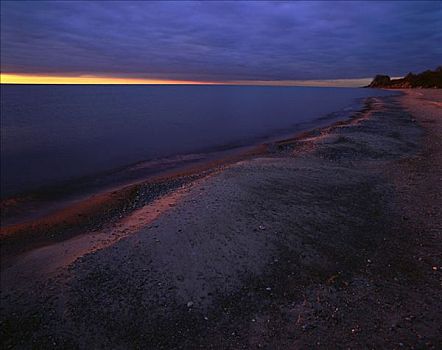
[{"x1": 1, "y1": 85, "x2": 392, "y2": 197}]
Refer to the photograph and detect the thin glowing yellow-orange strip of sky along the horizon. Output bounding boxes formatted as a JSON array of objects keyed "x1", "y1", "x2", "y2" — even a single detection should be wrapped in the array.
[{"x1": 0, "y1": 73, "x2": 380, "y2": 87}]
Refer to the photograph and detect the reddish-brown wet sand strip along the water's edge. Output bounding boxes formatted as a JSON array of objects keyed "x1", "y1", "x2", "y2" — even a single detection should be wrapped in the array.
[{"x1": 0, "y1": 97, "x2": 384, "y2": 258}]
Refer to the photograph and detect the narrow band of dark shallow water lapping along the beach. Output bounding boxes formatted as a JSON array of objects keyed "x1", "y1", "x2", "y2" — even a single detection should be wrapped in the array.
[{"x1": 0, "y1": 97, "x2": 370, "y2": 228}]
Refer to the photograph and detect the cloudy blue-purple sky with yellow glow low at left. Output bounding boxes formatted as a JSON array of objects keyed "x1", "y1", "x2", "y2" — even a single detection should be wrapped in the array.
[{"x1": 1, "y1": 1, "x2": 442, "y2": 85}]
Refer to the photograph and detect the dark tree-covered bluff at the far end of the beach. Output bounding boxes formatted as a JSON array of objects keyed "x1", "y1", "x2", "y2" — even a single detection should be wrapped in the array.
[{"x1": 367, "y1": 66, "x2": 442, "y2": 89}]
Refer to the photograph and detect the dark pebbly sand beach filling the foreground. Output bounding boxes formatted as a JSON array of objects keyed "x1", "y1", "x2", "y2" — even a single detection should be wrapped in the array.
[{"x1": 1, "y1": 90, "x2": 442, "y2": 349}]
